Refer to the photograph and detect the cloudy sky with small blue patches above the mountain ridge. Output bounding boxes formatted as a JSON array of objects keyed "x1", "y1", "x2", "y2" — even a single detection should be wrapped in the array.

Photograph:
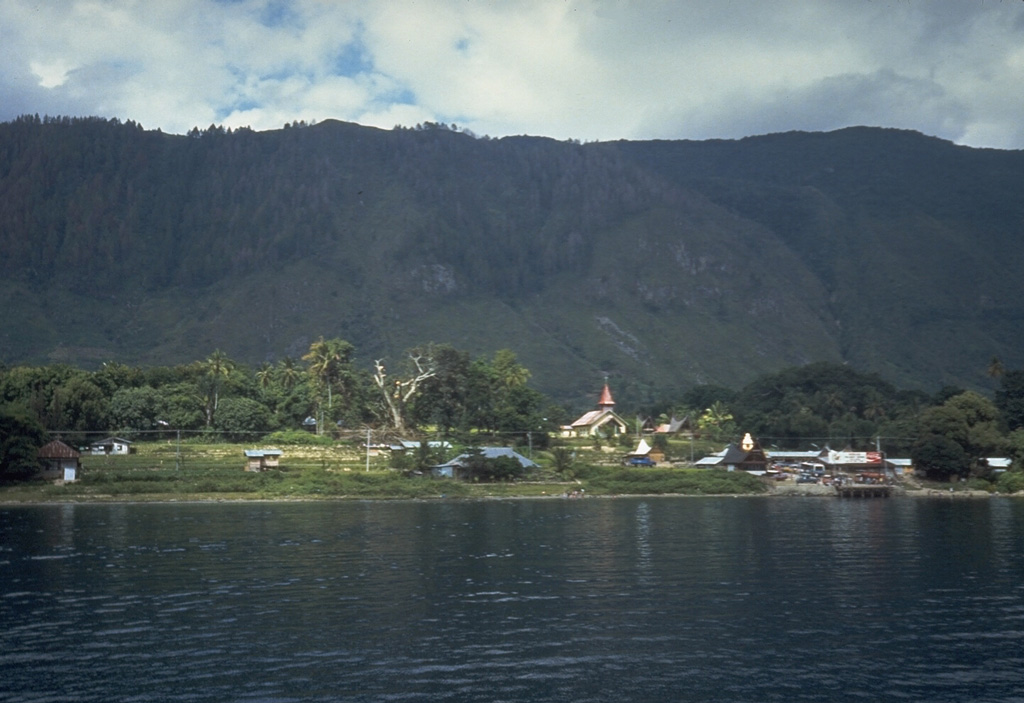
[{"x1": 0, "y1": 0, "x2": 1024, "y2": 148}]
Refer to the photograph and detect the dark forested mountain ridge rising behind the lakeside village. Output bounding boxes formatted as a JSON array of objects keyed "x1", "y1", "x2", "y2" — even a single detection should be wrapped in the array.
[{"x1": 0, "y1": 118, "x2": 1024, "y2": 405}]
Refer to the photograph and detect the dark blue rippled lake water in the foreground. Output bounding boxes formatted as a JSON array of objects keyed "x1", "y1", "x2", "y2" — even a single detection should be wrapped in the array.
[{"x1": 0, "y1": 498, "x2": 1024, "y2": 703}]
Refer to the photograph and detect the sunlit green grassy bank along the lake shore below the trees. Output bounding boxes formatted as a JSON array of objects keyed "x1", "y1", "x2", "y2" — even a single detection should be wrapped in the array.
[{"x1": 0, "y1": 442, "x2": 765, "y2": 502}]
